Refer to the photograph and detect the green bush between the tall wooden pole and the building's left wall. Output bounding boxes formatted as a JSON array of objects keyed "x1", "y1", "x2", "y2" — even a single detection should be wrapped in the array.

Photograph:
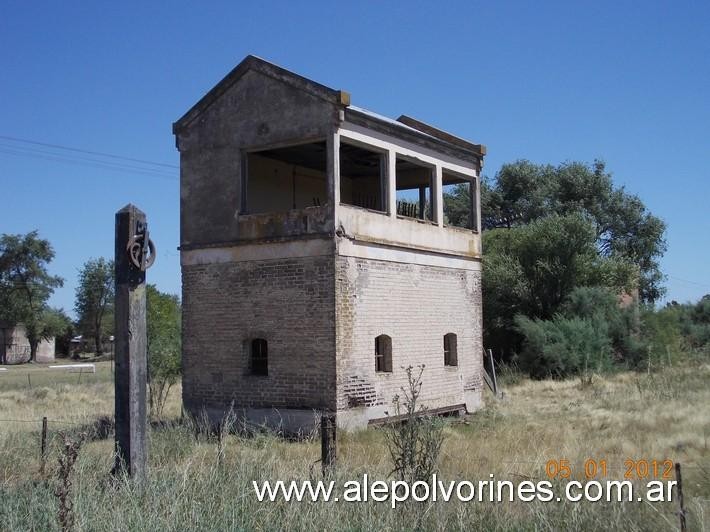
[{"x1": 146, "y1": 285, "x2": 181, "y2": 418}]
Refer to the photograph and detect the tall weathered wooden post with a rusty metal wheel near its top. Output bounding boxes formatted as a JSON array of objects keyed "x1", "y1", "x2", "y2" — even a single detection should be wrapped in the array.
[{"x1": 113, "y1": 204, "x2": 148, "y2": 481}]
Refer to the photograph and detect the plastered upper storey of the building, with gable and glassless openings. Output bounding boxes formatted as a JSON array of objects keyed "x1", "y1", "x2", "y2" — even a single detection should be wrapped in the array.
[{"x1": 173, "y1": 56, "x2": 485, "y2": 256}]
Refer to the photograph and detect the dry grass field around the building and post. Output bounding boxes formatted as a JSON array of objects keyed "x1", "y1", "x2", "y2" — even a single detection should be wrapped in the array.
[{"x1": 0, "y1": 362, "x2": 710, "y2": 531}]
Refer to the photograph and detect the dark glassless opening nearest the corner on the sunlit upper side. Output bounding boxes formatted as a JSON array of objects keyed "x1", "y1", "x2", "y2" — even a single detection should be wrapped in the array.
[{"x1": 340, "y1": 139, "x2": 387, "y2": 212}]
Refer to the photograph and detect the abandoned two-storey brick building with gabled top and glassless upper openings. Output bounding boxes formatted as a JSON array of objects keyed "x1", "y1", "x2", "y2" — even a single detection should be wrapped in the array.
[{"x1": 173, "y1": 56, "x2": 485, "y2": 430}]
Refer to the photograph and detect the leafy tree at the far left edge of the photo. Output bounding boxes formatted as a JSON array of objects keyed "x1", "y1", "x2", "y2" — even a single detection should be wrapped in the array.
[{"x1": 0, "y1": 231, "x2": 64, "y2": 361}]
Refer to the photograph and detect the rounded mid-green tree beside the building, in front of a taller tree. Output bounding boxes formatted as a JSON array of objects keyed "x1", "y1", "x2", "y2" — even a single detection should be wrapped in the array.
[{"x1": 483, "y1": 212, "x2": 637, "y2": 353}]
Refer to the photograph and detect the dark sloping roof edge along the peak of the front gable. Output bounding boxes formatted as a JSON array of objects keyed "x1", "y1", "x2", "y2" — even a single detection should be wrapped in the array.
[{"x1": 173, "y1": 55, "x2": 350, "y2": 133}]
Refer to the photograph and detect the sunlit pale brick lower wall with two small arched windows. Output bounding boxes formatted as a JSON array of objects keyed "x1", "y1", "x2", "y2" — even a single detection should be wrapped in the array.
[{"x1": 336, "y1": 257, "x2": 482, "y2": 418}]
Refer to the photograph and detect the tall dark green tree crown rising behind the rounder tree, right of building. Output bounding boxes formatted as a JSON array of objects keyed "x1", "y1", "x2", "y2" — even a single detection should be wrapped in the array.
[{"x1": 481, "y1": 160, "x2": 666, "y2": 302}]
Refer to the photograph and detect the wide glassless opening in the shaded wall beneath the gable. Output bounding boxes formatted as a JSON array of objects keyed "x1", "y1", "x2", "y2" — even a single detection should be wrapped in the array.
[{"x1": 242, "y1": 142, "x2": 328, "y2": 213}]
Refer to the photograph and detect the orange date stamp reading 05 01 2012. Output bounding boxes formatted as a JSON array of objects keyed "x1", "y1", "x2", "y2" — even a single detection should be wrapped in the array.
[{"x1": 545, "y1": 458, "x2": 674, "y2": 480}]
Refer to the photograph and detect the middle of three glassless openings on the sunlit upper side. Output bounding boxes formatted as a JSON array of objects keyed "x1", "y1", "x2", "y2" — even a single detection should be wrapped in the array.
[{"x1": 395, "y1": 156, "x2": 434, "y2": 221}]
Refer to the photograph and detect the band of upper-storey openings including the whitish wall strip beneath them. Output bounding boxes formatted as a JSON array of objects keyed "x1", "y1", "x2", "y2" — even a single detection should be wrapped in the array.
[{"x1": 238, "y1": 129, "x2": 480, "y2": 255}]
